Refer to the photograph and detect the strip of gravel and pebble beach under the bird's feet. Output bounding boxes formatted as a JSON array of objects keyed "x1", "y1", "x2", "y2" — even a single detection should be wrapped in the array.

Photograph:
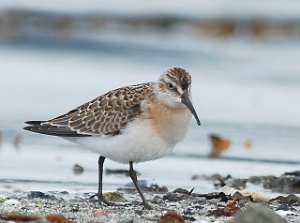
[{"x1": 0, "y1": 182, "x2": 300, "y2": 223}]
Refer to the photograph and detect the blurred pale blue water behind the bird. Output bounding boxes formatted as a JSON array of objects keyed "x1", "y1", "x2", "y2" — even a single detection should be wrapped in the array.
[{"x1": 0, "y1": 0, "x2": 300, "y2": 195}]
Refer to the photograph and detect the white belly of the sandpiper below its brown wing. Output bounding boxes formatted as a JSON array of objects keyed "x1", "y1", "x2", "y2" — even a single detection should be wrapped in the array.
[{"x1": 69, "y1": 120, "x2": 175, "y2": 163}]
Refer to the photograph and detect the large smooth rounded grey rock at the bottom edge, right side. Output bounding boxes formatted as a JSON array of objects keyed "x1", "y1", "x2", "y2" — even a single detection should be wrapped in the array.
[{"x1": 232, "y1": 205, "x2": 287, "y2": 223}]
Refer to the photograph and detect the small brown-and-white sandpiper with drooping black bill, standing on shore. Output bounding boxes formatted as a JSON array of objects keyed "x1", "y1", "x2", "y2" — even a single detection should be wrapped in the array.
[{"x1": 24, "y1": 68, "x2": 200, "y2": 208}]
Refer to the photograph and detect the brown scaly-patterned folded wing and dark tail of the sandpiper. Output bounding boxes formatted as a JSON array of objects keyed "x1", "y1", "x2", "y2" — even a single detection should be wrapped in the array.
[{"x1": 25, "y1": 83, "x2": 153, "y2": 137}]
